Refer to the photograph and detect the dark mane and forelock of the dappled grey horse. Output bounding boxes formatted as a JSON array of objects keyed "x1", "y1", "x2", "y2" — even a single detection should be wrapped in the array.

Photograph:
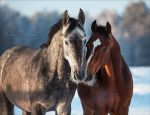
[{"x1": 41, "y1": 18, "x2": 84, "y2": 49}]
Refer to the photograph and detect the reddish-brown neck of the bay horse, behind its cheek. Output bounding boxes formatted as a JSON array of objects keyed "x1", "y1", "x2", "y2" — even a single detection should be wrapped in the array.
[{"x1": 102, "y1": 34, "x2": 122, "y2": 83}]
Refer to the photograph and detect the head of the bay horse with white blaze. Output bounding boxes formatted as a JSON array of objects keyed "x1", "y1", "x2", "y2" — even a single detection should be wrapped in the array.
[{"x1": 84, "y1": 20, "x2": 111, "y2": 85}]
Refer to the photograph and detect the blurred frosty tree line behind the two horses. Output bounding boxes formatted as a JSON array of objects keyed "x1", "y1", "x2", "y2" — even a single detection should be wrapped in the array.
[{"x1": 0, "y1": 2, "x2": 150, "y2": 66}]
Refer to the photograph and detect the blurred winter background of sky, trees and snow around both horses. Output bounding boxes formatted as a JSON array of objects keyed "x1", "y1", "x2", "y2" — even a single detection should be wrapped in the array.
[{"x1": 0, "y1": 0, "x2": 150, "y2": 115}]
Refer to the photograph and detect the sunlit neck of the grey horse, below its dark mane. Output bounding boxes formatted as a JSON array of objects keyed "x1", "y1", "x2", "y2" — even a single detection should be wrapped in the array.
[{"x1": 44, "y1": 31, "x2": 71, "y2": 79}]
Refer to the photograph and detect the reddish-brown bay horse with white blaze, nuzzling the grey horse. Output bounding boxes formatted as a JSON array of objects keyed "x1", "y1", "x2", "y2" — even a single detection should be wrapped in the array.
[{"x1": 77, "y1": 20, "x2": 133, "y2": 115}]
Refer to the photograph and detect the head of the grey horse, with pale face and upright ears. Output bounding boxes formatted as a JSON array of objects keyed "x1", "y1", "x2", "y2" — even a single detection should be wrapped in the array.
[{"x1": 61, "y1": 9, "x2": 86, "y2": 83}]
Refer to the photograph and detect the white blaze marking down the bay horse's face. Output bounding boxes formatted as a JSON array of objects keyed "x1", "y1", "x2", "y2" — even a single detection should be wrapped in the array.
[{"x1": 85, "y1": 38, "x2": 101, "y2": 77}]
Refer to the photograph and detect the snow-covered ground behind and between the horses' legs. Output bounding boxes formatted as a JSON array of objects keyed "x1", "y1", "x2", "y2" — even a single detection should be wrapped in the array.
[{"x1": 15, "y1": 67, "x2": 150, "y2": 115}]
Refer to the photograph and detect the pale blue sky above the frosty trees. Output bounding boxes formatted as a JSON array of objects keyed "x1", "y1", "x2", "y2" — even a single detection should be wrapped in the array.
[{"x1": 0, "y1": 0, "x2": 150, "y2": 17}]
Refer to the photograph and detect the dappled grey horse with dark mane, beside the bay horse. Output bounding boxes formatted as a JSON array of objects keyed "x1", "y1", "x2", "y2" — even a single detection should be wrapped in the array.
[{"x1": 0, "y1": 9, "x2": 86, "y2": 115}]
